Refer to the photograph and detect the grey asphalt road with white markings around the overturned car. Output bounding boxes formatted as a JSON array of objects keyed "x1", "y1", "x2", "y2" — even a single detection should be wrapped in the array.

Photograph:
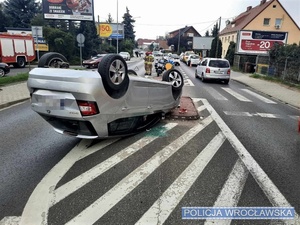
[{"x1": 0, "y1": 62, "x2": 300, "y2": 225}]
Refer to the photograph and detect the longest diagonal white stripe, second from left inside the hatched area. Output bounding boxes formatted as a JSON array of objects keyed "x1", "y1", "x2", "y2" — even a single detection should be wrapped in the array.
[{"x1": 67, "y1": 117, "x2": 213, "y2": 225}]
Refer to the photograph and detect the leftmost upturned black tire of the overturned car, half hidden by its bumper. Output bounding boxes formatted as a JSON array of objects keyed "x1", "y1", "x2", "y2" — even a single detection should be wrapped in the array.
[{"x1": 38, "y1": 52, "x2": 68, "y2": 68}]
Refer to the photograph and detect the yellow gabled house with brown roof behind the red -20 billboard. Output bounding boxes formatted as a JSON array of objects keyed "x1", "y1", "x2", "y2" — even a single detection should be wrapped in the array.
[{"x1": 219, "y1": 0, "x2": 300, "y2": 58}]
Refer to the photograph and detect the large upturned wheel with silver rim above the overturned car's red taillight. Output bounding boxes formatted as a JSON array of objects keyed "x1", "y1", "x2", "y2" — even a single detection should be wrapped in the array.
[{"x1": 98, "y1": 54, "x2": 129, "y2": 98}]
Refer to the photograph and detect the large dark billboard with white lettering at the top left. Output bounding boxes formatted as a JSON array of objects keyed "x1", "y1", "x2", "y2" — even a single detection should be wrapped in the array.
[{"x1": 42, "y1": 0, "x2": 94, "y2": 21}]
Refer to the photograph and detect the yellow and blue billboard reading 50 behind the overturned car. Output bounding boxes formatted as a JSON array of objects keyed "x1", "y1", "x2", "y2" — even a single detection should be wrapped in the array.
[{"x1": 97, "y1": 23, "x2": 124, "y2": 39}]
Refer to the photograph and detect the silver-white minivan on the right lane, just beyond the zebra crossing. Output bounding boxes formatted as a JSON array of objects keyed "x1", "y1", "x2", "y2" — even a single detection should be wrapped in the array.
[{"x1": 195, "y1": 58, "x2": 231, "y2": 84}]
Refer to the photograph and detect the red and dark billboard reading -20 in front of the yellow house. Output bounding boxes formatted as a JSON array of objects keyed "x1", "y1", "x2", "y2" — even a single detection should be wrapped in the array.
[{"x1": 237, "y1": 30, "x2": 288, "y2": 54}]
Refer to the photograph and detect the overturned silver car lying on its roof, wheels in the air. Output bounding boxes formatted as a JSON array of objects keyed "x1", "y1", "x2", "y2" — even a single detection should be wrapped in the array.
[{"x1": 27, "y1": 53, "x2": 183, "y2": 139}]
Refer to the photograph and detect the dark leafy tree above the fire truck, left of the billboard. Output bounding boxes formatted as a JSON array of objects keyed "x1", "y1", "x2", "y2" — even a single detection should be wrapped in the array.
[{"x1": 4, "y1": 0, "x2": 42, "y2": 28}]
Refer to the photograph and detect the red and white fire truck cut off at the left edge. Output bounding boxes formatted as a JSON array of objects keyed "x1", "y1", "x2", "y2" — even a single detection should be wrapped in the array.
[{"x1": 0, "y1": 33, "x2": 36, "y2": 68}]
